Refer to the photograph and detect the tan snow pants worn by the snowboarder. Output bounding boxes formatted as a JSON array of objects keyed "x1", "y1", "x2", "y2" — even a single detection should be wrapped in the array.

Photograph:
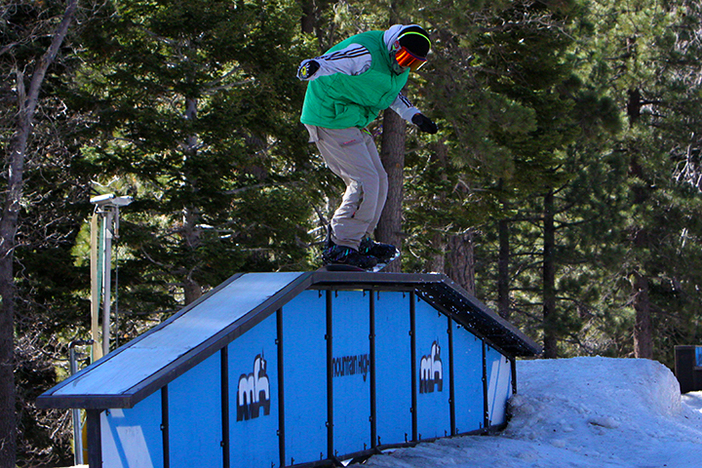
[{"x1": 306, "y1": 125, "x2": 388, "y2": 249}]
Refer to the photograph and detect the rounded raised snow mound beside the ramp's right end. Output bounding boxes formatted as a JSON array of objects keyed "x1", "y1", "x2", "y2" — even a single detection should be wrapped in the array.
[{"x1": 504, "y1": 358, "x2": 682, "y2": 443}]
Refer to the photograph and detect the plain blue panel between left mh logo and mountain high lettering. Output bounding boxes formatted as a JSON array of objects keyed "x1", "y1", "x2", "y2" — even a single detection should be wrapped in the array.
[{"x1": 283, "y1": 291, "x2": 327, "y2": 465}]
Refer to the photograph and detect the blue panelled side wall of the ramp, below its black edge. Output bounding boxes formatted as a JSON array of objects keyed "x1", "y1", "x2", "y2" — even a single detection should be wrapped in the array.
[{"x1": 97, "y1": 290, "x2": 512, "y2": 468}]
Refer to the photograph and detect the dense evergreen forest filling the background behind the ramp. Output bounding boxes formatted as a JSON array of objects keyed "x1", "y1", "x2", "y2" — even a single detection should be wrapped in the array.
[{"x1": 6, "y1": 0, "x2": 702, "y2": 466}]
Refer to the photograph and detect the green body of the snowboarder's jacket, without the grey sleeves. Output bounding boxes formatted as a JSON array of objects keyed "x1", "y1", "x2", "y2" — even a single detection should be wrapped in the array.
[{"x1": 300, "y1": 31, "x2": 409, "y2": 129}]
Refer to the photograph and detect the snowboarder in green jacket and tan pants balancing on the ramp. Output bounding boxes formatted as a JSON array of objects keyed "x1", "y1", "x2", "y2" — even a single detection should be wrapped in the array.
[{"x1": 297, "y1": 25, "x2": 437, "y2": 269}]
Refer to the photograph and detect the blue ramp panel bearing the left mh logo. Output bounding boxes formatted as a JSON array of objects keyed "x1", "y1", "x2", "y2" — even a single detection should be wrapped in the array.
[{"x1": 228, "y1": 314, "x2": 280, "y2": 468}]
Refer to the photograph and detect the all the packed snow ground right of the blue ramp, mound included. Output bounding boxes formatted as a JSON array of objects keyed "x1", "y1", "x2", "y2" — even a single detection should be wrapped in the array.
[{"x1": 359, "y1": 357, "x2": 702, "y2": 468}]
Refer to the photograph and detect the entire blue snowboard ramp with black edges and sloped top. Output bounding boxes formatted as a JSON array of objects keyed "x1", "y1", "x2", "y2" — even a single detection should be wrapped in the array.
[{"x1": 39, "y1": 274, "x2": 537, "y2": 468}]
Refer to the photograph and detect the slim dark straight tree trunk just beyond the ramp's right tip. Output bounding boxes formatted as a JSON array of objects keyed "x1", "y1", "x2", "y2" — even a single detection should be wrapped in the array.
[{"x1": 543, "y1": 190, "x2": 558, "y2": 359}]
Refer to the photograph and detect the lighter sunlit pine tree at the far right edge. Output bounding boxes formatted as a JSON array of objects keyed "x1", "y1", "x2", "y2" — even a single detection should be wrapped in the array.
[{"x1": 580, "y1": 2, "x2": 700, "y2": 363}]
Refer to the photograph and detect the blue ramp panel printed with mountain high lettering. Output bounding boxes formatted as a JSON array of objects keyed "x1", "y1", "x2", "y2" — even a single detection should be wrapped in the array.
[{"x1": 332, "y1": 291, "x2": 371, "y2": 456}]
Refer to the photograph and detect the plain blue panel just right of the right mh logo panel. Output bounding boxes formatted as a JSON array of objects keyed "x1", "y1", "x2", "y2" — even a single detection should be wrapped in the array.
[{"x1": 451, "y1": 320, "x2": 485, "y2": 434}]
